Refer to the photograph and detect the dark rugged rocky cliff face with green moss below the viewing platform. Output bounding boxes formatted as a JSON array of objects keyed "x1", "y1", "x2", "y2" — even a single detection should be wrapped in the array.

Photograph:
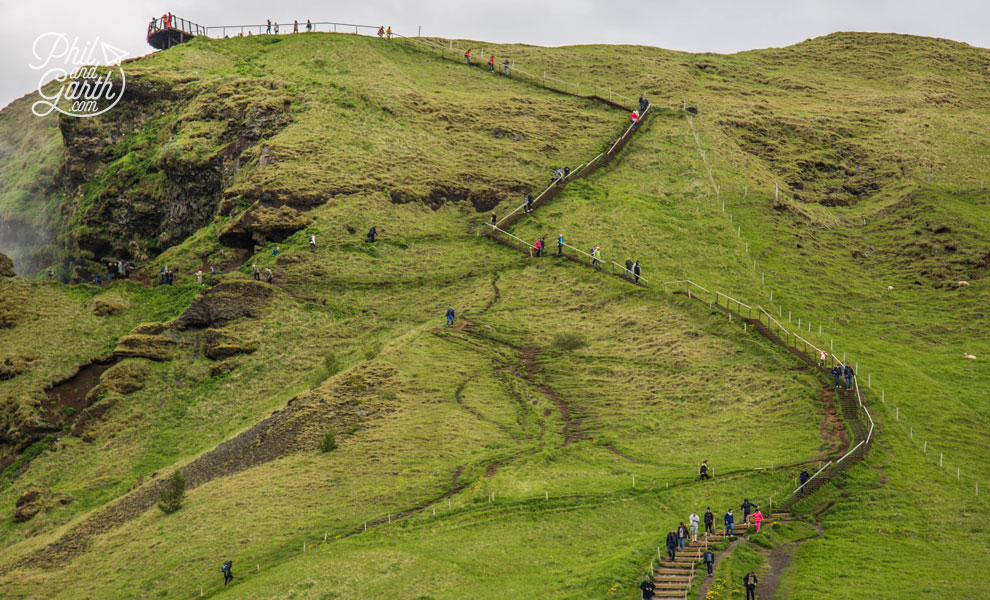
[{"x1": 59, "y1": 80, "x2": 290, "y2": 280}]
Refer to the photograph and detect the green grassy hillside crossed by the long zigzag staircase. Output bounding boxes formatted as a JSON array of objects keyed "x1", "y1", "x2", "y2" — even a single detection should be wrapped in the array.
[{"x1": 0, "y1": 34, "x2": 990, "y2": 598}]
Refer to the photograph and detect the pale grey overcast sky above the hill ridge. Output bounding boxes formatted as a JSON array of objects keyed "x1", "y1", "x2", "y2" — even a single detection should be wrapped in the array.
[{"x1": 0, "y1": 0, "x2": 990, "y2": 106}]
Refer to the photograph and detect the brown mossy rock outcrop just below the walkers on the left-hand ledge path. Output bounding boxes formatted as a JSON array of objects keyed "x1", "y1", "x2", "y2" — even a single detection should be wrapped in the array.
[{"x1": 172, "y1": 279, "x2": 274, "y2": 330}]
